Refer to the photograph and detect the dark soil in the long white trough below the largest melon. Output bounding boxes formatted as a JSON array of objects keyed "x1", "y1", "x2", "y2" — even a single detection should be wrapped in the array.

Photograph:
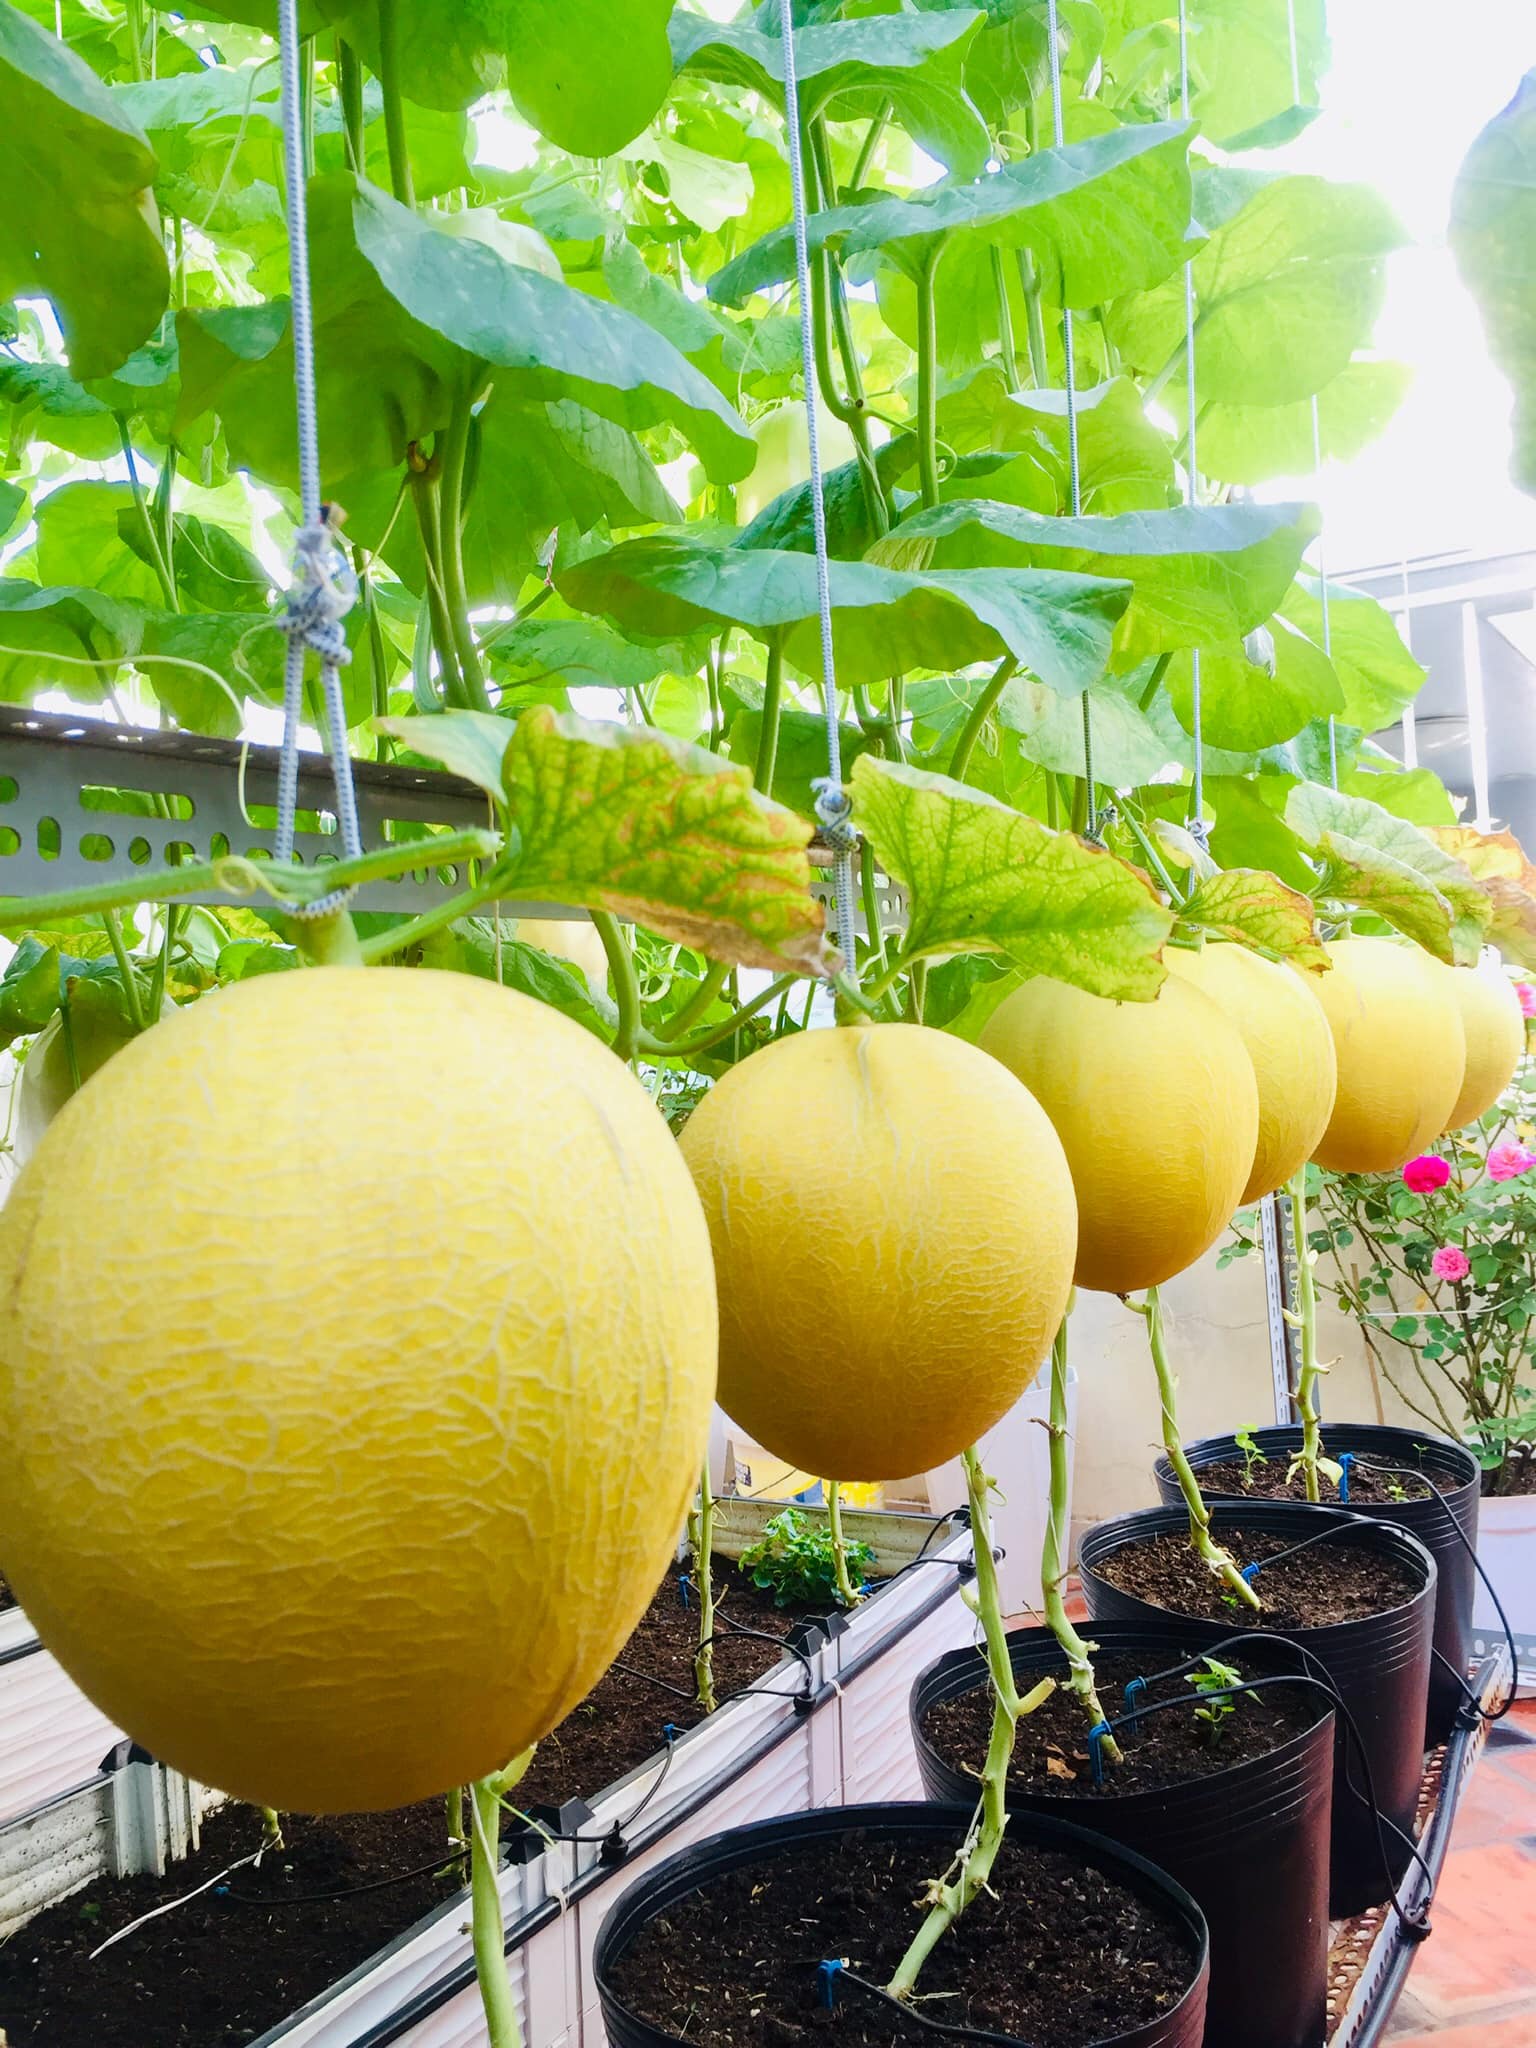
[{"x1": 0, "y1": 1559, "x2": 831, "y2": 2048}]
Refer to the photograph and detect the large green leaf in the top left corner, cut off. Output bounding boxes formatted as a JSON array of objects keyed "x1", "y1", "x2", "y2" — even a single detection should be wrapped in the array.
[{"x1": 0, "y1": 4, "x2": 170, "y2": 379}]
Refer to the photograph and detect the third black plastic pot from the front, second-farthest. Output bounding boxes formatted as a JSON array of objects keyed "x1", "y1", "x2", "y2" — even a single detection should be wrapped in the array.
[{"x1": 1079, "y1": 1501, "x2": 1436, "y2": 1919}]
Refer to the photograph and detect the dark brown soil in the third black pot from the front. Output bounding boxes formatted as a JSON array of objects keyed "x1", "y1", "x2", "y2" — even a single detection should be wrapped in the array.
[{"x1": 1096, "y1": 1524, "x2": 1423, "y2": 1628}]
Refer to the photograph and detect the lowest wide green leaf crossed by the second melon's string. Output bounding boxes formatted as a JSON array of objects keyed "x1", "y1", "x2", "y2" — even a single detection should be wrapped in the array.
[{"x1": 555, "y1": 535, "x2": 1130, "y2": 692}]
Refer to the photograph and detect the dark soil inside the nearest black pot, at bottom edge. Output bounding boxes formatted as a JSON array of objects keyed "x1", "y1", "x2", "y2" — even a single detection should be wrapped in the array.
[{"x1": 614, "y1": 1833, "x2": 1194, "y2": 2048}]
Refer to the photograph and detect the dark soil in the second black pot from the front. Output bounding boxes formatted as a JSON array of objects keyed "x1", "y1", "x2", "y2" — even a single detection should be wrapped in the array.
[{"x1": 924, "y1": 1653, "x2": 1323, "y2": 1802}]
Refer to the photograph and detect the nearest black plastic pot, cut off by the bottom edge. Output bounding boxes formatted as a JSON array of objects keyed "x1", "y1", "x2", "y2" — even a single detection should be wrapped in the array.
[{"x1": 592, "y1": 1798, "x2": 1210, "y2": 2048}]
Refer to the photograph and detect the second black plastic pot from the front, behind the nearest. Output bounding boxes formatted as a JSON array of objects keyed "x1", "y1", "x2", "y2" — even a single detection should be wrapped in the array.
[{"x1": 911, "y1": 1622, "x2": 1333, "y2": 2048}]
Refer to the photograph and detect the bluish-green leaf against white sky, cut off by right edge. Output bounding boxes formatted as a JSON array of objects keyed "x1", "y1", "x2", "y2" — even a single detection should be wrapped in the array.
[{"x1": 1450, "y1": 70, "x2": 1536, "y2": 492}]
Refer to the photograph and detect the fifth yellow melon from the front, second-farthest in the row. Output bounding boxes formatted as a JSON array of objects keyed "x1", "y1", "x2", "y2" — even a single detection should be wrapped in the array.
[{"x1": 1313, "y1": 938, "x2": 1466, "y2": 1174}]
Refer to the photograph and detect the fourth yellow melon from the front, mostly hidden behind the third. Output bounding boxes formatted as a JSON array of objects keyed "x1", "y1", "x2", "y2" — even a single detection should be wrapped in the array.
[{"x1": 1163, "y1": 944, "x2": 1337, "y2": 1202}]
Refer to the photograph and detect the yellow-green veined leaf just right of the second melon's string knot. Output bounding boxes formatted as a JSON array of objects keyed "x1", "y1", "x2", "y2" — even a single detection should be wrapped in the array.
[{"x1": 852, "y1": 754, "x2": 1174, "y2": 1001}]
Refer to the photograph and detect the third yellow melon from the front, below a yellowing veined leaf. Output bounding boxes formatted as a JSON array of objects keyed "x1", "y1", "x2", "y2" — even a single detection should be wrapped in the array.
[{"x1": 981, "y1": 977, "x2": 1260, "y2": 1294}]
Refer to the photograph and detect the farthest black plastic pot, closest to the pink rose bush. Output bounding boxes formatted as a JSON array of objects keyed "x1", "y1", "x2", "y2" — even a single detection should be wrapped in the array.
[{"x1": 1153, "y1": 1421, "x2": 1483, "y2": 1743}]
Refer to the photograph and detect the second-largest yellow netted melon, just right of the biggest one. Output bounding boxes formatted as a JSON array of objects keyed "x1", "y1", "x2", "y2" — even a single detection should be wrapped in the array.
[{"x1": 682, "y1": 1024, "x2": 1075, "y2": 1479}]
